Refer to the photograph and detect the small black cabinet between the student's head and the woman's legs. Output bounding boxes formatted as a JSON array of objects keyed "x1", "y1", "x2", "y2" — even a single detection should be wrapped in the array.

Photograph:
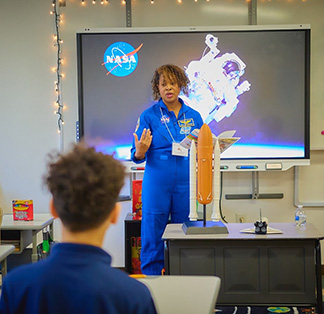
[{"x1": 125, "y1": 213, "x2": 141, "y2": 274}]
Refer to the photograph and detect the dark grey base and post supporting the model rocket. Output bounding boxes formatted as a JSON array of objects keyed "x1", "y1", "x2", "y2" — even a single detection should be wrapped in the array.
[{"x1": 182, "y1": 204, "x2": 228, "y2": 234}]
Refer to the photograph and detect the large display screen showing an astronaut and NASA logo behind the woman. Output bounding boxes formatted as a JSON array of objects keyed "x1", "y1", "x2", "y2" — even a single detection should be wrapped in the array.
[{"x1": 77, "y1": 25, "x2": 310, "y2": 170}]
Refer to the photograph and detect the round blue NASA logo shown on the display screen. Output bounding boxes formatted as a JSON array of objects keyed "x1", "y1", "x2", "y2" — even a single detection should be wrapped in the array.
[{"x1": 102, "y1": 41, "x2": 143, "y2": 77}]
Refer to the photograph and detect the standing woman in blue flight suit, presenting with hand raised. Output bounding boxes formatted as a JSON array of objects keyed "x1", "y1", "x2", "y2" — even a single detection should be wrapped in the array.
[{"x1": 131, "y1": 64, "x2": 203, "y2": 275}]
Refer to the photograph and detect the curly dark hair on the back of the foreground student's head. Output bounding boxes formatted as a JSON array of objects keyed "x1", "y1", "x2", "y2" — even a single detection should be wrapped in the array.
[{"x1": 45, "y1": 144, "x2": 125, "y2": 232}]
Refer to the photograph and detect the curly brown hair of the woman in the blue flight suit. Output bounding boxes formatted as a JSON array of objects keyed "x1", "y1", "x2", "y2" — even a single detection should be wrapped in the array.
[{"x1": 151, "y1": 64, "x2": 190, "y2": 100}]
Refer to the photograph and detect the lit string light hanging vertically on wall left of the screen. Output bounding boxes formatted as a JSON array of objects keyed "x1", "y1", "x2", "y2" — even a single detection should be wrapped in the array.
[{"x1": 50, "y1": 0, "x2": 64, "y2": 133}]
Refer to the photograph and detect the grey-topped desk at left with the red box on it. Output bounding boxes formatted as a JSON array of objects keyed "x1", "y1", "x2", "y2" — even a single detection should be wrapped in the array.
[{"x1": 1, "y1": 213, "x2": 54, "y2": 263}]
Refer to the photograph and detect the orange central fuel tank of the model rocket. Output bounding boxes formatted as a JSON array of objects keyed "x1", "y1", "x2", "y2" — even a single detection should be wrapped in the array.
[{"x1": 197, "y1": 124, "x2": 213, "y2": 204}]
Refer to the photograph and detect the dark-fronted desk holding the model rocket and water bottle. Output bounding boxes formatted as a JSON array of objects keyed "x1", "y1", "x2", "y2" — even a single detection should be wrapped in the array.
[{"x1": 162, "y1": 223, "x2": 323, "y2": 314}]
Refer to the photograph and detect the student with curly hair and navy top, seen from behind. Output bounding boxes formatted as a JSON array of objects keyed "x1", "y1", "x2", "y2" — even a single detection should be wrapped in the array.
[{"x1": 0, "y1": 144, "x2": 156, "y2": 314}]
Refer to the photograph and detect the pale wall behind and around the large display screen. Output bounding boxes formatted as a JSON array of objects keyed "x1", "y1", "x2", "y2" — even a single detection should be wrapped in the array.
[{"x1": 0, "y1": 0, "x2": 324, "y2": 267}]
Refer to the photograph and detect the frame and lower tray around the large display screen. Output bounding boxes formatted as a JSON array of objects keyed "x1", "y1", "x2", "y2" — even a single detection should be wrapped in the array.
[{"x1": 76, "y1": 24, "x2": 311, "y2": 171}]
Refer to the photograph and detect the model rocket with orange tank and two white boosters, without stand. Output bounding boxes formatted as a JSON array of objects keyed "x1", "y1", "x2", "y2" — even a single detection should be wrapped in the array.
[{"x1": 189, "y1": 124, "x2": 221, "y2": 221}]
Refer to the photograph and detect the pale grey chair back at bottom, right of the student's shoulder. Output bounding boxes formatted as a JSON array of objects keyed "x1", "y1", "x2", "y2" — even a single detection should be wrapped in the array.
[{"x1": 137, "y1": 276, "x2": 221, "y2": 314}]
